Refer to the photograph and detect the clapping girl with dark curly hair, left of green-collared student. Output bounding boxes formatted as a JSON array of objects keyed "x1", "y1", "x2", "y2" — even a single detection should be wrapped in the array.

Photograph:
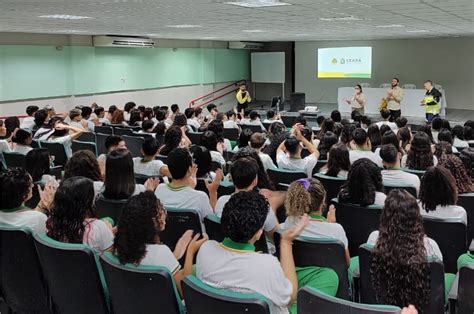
[{"x1": 113, "y1": 192, "x2": 208, "y2": 294}]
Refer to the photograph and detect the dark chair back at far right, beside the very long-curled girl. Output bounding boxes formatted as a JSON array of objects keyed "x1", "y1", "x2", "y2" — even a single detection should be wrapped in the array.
[{"x1": 423, "y1": 217, "x2": 468, "y2": 274}]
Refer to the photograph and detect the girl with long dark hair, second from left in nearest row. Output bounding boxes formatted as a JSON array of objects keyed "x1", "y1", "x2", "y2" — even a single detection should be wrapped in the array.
[{"x1": 46, "y1": 177, "x2": 114, "y2": 253}]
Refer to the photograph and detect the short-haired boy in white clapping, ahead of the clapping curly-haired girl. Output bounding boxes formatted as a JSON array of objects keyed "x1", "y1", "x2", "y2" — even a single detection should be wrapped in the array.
[{"x1": 155, "y1": 148, "x2": 222, "y2": 221}]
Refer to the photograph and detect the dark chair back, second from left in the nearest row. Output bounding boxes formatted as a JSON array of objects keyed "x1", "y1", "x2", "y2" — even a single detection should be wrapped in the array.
[{"x1": 35, "y1": 234, "x2": 109, "y2": 314}]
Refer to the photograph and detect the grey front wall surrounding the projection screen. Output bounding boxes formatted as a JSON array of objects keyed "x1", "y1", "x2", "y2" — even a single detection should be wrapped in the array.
[{"x1": 295, "y1": 38, "x2": 474, "y2": 110}]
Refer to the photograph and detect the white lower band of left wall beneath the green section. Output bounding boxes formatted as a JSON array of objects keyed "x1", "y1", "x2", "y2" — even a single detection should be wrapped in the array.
[{"x1": 0, "y1": 82, "x2": 236, "y2": 118}]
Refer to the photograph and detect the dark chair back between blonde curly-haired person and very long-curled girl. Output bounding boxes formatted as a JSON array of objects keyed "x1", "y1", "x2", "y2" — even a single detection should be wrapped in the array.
[{"x1": 331, "y1": 198, "x2": 382, "y2": 257}]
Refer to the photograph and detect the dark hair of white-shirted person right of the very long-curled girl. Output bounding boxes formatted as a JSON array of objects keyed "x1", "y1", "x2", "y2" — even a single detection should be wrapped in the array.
[{"x1": 419, "y1": 166, "x2": 458, "y2": 212}]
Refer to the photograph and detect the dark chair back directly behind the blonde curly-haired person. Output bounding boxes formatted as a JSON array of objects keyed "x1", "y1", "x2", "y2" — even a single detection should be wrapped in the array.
[{"x1": 273, "y1": 230, "x2": 351, "y2": 300}]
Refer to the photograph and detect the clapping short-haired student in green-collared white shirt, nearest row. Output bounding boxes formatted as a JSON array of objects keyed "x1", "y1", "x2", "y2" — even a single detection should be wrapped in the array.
[{"x1": 196, "y1": 192, "x2": 338, "y2": 313}]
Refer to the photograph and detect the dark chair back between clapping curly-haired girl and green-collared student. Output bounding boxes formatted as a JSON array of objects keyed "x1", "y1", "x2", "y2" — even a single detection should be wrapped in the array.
[{"x1": 160, "y1": 208, "x2": 202, "y2": 251}]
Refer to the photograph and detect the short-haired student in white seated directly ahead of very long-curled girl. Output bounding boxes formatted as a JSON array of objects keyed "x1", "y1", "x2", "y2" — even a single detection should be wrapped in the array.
[{"x1": 380, "y1": 144, "x2": 420, "y2": 195}]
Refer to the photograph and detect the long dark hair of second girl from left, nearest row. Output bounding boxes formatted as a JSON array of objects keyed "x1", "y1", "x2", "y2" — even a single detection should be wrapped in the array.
[{"x1": 46, "y1": 177, "x2": 95, "y2": 243}]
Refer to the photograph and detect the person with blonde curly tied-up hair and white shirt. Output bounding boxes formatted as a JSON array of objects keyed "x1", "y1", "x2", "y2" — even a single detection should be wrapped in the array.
[{"x1": 282, "y1": 178, "x2": 350, "y2": 266}]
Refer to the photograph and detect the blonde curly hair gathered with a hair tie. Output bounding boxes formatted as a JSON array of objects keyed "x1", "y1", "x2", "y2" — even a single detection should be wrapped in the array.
[{"x1": 285, "y1": 178, "x2": 326, "y2": 217}]
